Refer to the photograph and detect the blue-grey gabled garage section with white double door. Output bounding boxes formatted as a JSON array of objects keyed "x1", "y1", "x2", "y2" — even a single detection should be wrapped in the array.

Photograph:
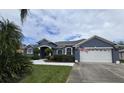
[{"x1": 75, "y1": 36, "x2": 119, "y2": 63}]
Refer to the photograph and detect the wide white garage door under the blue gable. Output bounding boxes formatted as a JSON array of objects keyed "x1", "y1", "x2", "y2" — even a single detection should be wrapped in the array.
[{"x1": 80, "y1": 49, "x2": 112, "y2": 63}]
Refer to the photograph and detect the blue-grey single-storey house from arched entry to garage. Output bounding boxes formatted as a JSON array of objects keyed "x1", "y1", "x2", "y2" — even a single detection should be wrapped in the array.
[{"x1": 38, "y1": 36, "x2": 119, "y2": 63}]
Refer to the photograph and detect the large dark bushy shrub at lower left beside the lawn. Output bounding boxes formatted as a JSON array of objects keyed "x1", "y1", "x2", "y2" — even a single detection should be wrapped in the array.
[{"x1": 0, "y1": 54, "x2": 32, "y2": 82}]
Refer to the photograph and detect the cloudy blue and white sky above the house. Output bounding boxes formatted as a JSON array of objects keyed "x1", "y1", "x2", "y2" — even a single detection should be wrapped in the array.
[{"x1": 0, "y1": 9, "x2": 124, "y2": 44}]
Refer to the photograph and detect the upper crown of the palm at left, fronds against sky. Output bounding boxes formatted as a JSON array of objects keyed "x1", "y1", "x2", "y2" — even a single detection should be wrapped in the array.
[{"x1": 0, "y1": 19, "x2": 23, "y2": 54}]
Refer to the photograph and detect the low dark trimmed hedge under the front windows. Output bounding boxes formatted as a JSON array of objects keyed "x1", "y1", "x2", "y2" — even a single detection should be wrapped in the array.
[{"x1": 50, "y1": 55, "x2": 75, "y2": 62}]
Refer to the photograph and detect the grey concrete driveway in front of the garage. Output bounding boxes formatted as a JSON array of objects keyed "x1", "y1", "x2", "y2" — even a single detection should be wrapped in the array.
[{"x1": 67, "y1": 63, "x2": 124, "y2": 83}]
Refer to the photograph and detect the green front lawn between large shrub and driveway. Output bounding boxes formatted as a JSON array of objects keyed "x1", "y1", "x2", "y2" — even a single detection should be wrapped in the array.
[{"x1": 20, "y1": 65, "x2": 72, "y2": 83}]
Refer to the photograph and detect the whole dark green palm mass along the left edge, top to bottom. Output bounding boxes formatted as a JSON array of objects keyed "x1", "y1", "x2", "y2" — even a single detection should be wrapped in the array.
[{"x1": 0, "y1": 19, "x2": 31, "y2": 82}]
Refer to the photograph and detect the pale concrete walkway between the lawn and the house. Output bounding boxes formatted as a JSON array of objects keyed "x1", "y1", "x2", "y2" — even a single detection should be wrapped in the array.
[{"x1": 32, "y1": 59, "x2": 75, "y2": 66}]
